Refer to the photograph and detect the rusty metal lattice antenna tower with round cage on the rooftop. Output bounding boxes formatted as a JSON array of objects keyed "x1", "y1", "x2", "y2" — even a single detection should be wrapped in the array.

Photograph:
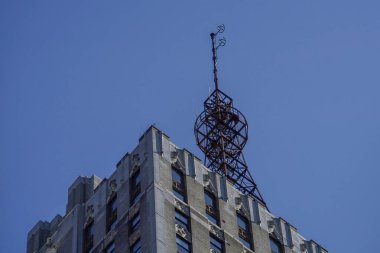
[{"x1": 194, "y1": 25, "x2": 268, "y2": 209}]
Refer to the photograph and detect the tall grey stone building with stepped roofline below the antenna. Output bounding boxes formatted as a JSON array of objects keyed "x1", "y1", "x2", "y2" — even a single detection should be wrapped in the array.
[{"x1": 27, "y1": 126, "x2": 327, "y2": 253}]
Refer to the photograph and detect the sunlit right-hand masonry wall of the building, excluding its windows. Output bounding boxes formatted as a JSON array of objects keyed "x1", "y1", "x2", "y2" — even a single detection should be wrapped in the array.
[{"x1": 148, "y1": 129, "x2": 327, "y2": 253}]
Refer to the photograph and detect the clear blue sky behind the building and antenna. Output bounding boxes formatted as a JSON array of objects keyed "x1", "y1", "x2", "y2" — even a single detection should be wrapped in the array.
[{"x1": 0, "y1": 0, "x2": 380, "y2": 253}]
